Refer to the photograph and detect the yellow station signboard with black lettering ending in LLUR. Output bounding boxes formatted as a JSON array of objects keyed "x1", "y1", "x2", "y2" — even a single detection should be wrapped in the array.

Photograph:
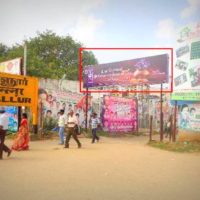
[{"x1": 0, "y1": 73, "x2": 38, "y2": 124}]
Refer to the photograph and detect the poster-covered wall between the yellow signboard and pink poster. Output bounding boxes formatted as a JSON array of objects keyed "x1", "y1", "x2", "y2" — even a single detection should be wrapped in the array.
[{"x1": 39, "y1": 79, "x2": 91, "y2": 130}]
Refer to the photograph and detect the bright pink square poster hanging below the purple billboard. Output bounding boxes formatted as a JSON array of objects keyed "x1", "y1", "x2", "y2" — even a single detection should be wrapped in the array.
[{"x1": 102, "y1": 96, "x2": 138, "y2": 132}]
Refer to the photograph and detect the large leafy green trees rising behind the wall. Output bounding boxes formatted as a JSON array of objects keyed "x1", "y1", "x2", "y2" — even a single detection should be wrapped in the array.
[{"x1": 0, "y1": 31, "x2": 97, "y2": 80}]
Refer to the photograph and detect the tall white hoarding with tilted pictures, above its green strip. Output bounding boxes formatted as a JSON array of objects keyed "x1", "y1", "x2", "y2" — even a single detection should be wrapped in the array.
[{"x1": 173, "y1": 22, "x2": 200, "y2": 90}]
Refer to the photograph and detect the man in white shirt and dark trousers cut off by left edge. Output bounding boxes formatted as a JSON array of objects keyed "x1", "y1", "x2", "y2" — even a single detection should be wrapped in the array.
[{"x1": 0, "y1": 108, "x2": 12, "y2": 159}]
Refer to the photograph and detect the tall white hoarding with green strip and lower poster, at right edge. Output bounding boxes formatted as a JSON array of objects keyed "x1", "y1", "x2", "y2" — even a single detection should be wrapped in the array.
[{"x1": 171, "y1": 22, "x2": 200, "y2": 138}]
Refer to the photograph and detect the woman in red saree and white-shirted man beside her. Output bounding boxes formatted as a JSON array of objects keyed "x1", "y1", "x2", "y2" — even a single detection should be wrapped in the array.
[{"x1": 0, "y1": 107, "x2": 29, "y2": 159}]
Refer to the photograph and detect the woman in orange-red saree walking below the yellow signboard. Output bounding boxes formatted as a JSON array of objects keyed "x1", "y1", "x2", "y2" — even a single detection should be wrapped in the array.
[{"x1": 12, "y1": 113, "x2": 29, "y2": 151}]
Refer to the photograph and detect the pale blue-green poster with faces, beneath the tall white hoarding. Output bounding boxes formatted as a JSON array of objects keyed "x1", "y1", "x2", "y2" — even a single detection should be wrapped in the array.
[{"x1": 178, "y1": 103, "x2": 200, "y2": 133}]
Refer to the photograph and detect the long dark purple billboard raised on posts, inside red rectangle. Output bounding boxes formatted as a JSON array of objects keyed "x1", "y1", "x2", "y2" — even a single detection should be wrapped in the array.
[{"x1": 83, "y1": 54, "x2": 169, "y2": 88}]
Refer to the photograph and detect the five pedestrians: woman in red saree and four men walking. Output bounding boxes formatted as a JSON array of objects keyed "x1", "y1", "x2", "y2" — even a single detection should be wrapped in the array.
[{"x1": 0, "y1": 107, "x2": 100, "y2": 159}]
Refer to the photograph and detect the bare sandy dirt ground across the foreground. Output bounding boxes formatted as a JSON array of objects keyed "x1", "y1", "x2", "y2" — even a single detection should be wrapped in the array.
[{"x1": 0, "y1": 136, "x2": 200, "y2": 200}]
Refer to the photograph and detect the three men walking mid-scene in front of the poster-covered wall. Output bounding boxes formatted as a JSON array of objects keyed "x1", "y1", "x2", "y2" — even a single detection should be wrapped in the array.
[{"x1": 58, "y1": 110, "x2": 100, "y2": 148}]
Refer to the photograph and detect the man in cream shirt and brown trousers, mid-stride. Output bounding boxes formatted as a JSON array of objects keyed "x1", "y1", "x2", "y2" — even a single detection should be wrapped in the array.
[{"x1": 65, "y1": 110, "x2": 81, "y2": 148}]
